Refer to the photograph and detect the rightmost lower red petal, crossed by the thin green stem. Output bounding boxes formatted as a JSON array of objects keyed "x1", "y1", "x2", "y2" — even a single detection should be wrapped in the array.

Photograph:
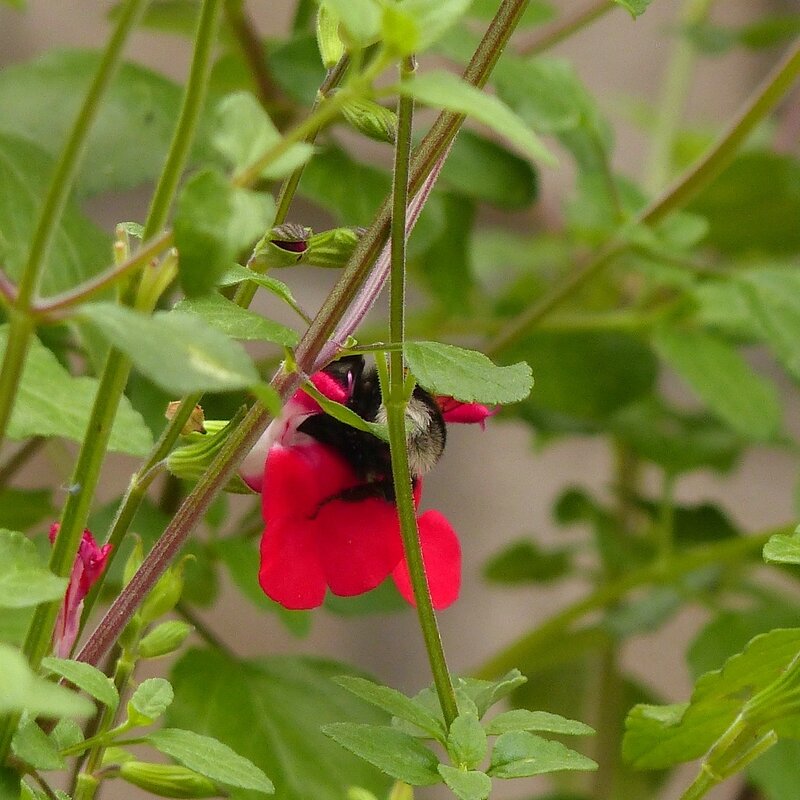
[{"x1": 392, "y1": 510, "x2": 461, "y2": 609}]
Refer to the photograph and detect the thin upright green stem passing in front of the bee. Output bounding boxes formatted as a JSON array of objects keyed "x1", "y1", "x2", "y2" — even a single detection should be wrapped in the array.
[{"x1": 385, "y1": 59, "x2": 458, "y2": 728}]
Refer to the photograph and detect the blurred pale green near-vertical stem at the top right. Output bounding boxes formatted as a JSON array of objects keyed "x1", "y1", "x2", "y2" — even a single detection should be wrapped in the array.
[{"x1": 644, "y1": 0, "x2": 713, "y2": 193}]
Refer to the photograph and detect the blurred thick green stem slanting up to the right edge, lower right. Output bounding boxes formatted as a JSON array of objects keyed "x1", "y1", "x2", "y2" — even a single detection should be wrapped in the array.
[{"x1": 473, "y1": 525, "x2": 780, "y2": 679}]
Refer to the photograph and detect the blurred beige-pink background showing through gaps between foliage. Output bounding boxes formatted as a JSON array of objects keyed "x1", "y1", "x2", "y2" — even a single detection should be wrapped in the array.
[{"x1": 0, "y1": 0, "x2": 800, "y2": 800}]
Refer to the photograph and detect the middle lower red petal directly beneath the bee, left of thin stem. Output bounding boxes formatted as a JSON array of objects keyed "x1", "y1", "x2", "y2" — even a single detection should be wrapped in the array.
[{"x1": 316, "y1": 497, "x2": 403, "y2": 597}]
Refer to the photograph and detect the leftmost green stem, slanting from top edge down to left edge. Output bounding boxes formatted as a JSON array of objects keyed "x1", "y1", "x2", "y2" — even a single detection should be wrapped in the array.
[{"x1": 0, "y1": 0, "x2": 146, "y2": 456}]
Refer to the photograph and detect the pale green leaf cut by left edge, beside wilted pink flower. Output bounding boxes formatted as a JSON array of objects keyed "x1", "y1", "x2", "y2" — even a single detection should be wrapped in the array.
[{"x1": 0, "y1": 528, "x2": 67, "y2": 608}]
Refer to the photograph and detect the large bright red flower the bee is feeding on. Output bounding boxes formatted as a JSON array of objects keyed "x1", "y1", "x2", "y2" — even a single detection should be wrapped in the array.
[{"x1": 241, "y1": 372, "x2": 490, "y2": 609}]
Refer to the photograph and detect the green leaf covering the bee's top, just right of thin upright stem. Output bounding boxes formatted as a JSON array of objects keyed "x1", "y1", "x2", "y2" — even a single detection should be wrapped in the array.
[{"x1": 404, "y1": 342, "x2": 533, "y2": 404}]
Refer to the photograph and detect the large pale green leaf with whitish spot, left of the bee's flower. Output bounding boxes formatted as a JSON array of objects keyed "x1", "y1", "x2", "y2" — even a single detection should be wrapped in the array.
[{"x1": 79, "y1": 303, "x2": 258, "y2": 396}]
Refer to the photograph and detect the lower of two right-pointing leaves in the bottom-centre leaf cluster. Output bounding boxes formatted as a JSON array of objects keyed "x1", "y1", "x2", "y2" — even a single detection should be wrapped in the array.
[{"x1": 489, "y1": 731, "x2": 597, "y2": 778}]
